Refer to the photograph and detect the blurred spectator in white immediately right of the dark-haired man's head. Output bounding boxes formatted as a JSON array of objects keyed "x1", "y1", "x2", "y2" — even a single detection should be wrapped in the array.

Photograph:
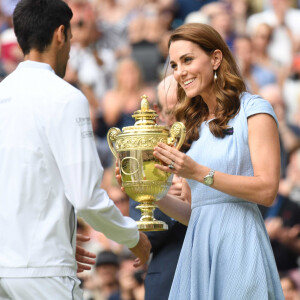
[{"x1": 65, "y1": 0, "x2": 116, "y2": 111}]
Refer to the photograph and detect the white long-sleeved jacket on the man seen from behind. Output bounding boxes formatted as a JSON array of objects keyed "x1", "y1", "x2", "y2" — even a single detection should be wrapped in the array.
[{"x1": 0, "y1": 61, "x2": 139, "y2": 277}]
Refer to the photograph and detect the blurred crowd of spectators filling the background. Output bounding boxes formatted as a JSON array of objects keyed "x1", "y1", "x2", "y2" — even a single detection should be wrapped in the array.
[{"x1": 0, "y1": 0, "x2": 300, "y2": 300}]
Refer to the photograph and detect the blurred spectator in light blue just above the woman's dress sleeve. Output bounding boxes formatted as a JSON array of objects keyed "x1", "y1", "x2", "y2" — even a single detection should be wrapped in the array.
[{"x1": 233, "y1": 36, "x2": 277, "y2": 94}]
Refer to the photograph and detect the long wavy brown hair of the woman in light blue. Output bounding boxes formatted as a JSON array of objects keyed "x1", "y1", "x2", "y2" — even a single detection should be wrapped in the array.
[{"x1": 169, "y1": 23, "x2": 246, "y2": 151}]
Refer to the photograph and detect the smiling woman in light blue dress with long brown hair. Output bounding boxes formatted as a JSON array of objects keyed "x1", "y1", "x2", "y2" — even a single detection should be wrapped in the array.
[{"x1": 154, "y1": 24, "x2": 284, "y2": 300}]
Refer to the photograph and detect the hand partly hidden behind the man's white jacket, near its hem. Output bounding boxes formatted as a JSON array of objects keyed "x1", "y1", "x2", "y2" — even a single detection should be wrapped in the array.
[{"x1": 75, "y1": 234, "x2": 96, "y2": 273}]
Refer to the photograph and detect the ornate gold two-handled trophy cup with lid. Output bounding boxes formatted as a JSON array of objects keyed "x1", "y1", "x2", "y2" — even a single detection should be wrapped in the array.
[{"x1": 107, "y1": 95, "x2": 185, "y2": 231}]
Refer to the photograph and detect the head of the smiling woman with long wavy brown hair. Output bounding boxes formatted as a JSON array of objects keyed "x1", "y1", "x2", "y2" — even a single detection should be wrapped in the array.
[{"x1": 169, "y1": 24, "x2": 246, "y2": 152}]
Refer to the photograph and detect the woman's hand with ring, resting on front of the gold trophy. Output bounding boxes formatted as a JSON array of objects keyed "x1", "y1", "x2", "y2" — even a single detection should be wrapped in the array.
[{"x1": 153, "y1": 143, "x2": 199, "y2": 179}]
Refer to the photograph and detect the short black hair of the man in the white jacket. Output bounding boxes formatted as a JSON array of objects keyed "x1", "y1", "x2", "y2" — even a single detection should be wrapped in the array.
[{"x1": 13, "y1": 0, "x2": 73, "y2": 55}]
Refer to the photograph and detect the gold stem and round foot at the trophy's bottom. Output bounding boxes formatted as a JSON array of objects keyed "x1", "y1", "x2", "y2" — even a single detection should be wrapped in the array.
[{"x1": 136, "y1": 202, "x2": 168, "y2": 231}]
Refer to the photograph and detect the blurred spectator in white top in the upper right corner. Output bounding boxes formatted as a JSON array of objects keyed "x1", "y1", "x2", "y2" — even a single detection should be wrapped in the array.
[{"x1": 247, "y1": 0, "x2": 300, "y2": 66}]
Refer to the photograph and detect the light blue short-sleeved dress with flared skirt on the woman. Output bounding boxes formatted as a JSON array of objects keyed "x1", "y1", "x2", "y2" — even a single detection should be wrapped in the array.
[{"x1": 169, "y1": 93, "x2": 284, "y2": 300}]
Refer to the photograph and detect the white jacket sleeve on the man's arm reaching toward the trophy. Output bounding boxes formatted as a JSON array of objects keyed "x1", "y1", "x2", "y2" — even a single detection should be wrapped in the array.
[{"x1": 47, "y1": 90, "x2": 139, "y2": 248}]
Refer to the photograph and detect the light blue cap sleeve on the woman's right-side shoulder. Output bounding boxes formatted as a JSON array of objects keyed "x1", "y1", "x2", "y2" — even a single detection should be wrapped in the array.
[{"x1": 241, "y1": 93, "x2": 278, "y2": 126}]
